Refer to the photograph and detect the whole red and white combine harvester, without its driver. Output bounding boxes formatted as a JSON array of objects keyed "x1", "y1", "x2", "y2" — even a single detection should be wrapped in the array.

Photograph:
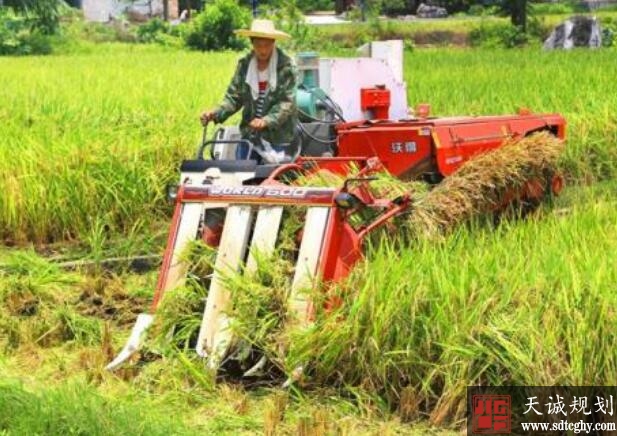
[{"x1": 108, "y1": 41, "x2": 565, "y2": 375}]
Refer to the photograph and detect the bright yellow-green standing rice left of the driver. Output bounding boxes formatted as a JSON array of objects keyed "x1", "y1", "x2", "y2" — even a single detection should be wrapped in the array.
[{"x1": 0, "y1": 48, "x2": 235, "y2": 243}]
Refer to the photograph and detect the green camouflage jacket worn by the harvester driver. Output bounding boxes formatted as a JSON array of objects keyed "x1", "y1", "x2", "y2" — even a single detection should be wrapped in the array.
[{"x1": 214, "y1": 47, "x2": 298, "y2": 145}]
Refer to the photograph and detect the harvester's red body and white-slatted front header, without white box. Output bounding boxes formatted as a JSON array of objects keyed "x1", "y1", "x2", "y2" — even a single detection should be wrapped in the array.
[{"x1": 108, "y1": 109, "x2": 566, "y2": 375}]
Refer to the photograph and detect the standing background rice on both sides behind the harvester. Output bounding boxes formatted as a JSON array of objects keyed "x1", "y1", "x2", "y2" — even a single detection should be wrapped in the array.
[{"x1": 0, "y1": 46, "x2": 617, "y2": 244}]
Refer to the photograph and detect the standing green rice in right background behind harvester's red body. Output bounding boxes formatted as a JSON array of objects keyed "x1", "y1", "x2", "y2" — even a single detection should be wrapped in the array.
[{"x1": 405, "y1": 49, "x2": 617, "y2": 182}]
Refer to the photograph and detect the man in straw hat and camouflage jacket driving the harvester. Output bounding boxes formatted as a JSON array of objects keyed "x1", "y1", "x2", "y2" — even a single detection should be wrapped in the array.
[{"x1": 201, "y1": 20, "x2": 297, "y2": 163}]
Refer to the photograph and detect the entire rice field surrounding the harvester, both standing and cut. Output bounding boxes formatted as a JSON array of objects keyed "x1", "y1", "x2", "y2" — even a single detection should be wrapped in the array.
[{"x1": 0, "y1": 46, "x2": 617, "y2": 434}]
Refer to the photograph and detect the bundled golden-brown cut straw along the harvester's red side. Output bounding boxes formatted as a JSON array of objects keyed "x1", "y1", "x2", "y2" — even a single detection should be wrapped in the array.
[{"x1": 407, "y1": 132, "x2": 563, "y2": 237}]
